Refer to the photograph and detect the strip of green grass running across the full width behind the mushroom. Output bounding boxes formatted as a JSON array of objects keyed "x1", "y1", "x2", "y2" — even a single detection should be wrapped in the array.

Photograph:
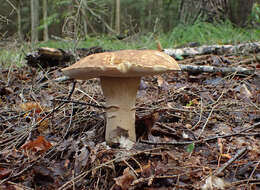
[{"x1": 0, "y1": 22, "x2": 260, "y2": 67}]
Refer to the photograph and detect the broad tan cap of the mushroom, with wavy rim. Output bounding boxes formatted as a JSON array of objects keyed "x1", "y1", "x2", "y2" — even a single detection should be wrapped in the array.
[{"x1": 62, "y1": 50, "x2": 180, "y2": 80}]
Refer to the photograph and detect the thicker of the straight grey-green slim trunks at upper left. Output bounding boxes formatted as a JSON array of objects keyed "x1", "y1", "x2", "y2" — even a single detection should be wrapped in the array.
[{"x1": 31, "y1": 0, "x2": 39, "y2": 43}]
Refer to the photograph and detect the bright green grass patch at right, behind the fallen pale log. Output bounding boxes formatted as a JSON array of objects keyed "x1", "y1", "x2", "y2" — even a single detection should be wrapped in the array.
[{"x1": 160, "y1": 21, "x2": 260, "y2": 47}]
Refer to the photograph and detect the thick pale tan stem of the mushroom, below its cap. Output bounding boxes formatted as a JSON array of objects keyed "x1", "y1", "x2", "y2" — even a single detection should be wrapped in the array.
[{"x1": 101, "y1": 77, "x2": 141, "y2": 144}]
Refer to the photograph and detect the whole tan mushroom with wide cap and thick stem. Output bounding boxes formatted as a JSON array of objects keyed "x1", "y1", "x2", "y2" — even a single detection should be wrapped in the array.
[{"x1": 62, "y1": 50, "x2": 180, "y2": 145}]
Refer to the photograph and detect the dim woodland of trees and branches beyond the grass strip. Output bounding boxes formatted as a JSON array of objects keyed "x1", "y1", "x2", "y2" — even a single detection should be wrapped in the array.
[{"x1": 0, "y1": 0, "x2": 259, "y2": 42}]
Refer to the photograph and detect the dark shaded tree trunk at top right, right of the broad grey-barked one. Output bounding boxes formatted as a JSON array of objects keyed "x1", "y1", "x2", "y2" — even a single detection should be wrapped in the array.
[{"x1": 228, "y1": 0, "x2": 254, "y2": 27}]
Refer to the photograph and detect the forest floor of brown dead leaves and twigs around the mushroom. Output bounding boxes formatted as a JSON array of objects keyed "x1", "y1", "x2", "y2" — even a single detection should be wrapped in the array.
[{"x1": 0, "y1": 42, "x2": 260, "y2": 190}]
